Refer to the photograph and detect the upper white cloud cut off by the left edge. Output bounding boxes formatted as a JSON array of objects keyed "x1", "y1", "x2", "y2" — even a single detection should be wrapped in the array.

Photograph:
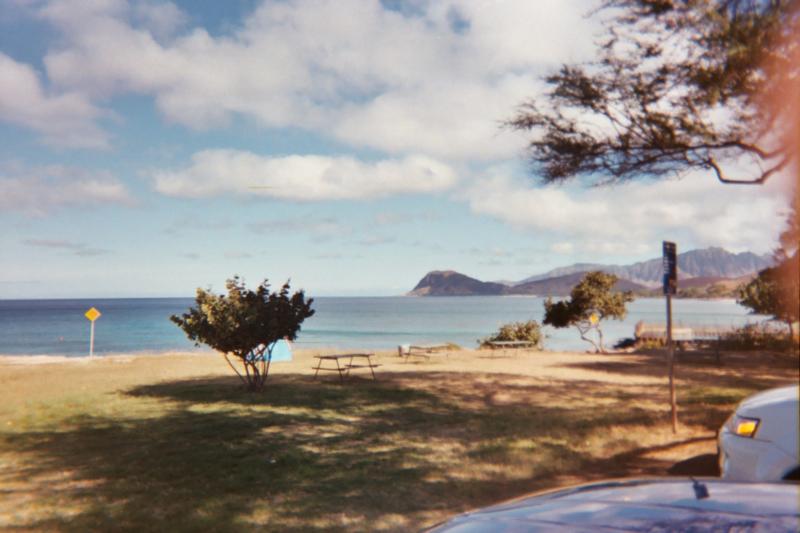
[{"x1": 0, "y1": 52, "x2": 108, "y2": 148}]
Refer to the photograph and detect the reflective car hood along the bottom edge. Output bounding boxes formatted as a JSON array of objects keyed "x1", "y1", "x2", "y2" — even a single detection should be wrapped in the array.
[{"x1": 433, "y1": 479, "x2": 800, "y2": 533}]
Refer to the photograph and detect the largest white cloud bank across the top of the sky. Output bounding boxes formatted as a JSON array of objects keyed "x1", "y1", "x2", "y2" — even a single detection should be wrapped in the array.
[{"x1": 40, "y1": 0, "x2": 594, "y2": 159}]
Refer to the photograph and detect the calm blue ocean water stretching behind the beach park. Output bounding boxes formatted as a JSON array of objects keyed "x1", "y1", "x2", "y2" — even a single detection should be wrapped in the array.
[{"x1": 0, "y1": 296, "x2": 766, "y2": 356}]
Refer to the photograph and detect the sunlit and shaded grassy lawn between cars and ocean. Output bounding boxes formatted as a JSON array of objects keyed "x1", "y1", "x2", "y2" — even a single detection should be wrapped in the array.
[{"x1": 0, "y1": 354, "x2": 797, "y2": 531}]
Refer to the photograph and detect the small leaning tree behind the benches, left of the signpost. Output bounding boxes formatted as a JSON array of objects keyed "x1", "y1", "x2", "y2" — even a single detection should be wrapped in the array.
[{"x1": 544, "y1": 271, "x2": 633, "y2": 353}]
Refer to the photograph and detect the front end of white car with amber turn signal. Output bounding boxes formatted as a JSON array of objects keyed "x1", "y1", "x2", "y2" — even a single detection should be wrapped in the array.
[{"x1": 718, "y1": 385, "x2": 800, "y2": 481}]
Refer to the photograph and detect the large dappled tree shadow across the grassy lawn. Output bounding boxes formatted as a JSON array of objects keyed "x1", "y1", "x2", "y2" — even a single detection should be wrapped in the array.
[{"x1": 2, "y1": 372, "x2": 736, "y2": 531}]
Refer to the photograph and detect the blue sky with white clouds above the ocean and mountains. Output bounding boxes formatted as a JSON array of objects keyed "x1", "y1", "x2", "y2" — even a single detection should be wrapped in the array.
[{"x1": 0, "y1": 0, "x2": 788, "y2": 298}]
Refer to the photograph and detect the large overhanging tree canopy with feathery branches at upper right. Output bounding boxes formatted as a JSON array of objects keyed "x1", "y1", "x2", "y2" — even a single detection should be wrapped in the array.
[{"x1": 508, "y1": 0, "x2": 800, "y2": 183}]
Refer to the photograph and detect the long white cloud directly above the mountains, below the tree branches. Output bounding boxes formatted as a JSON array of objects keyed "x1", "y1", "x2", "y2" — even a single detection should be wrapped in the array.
[{"x1": 464, "y1": 169, "x2": 790, "y2": 255}]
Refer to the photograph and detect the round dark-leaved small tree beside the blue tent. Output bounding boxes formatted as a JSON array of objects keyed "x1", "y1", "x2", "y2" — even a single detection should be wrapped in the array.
[{"x1": 170, "y1": 276, "x2": 314, "y2": 390}]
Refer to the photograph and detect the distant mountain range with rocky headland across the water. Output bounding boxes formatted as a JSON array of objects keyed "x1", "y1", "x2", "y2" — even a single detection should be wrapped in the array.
[{"x1": 409, "y1": 248, "x2": 772, "y2": 297}]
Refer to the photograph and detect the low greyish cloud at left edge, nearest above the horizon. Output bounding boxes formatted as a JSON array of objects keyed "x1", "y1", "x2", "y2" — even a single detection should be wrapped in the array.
[{"x1": 0, "y1": 165, "x2": 134, "y2": 216}]
